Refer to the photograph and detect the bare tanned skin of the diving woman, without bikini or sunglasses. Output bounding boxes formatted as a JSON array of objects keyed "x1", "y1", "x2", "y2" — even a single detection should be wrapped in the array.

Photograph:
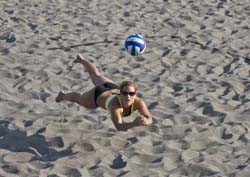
[{"x1": 55, "y1": 54, "x2": 152, "y2": 131}]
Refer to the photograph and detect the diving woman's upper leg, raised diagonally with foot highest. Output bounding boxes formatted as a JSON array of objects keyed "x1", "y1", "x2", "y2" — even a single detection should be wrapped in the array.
[{"x1": 74, "y1": 54, "x2": 114, "y2": 86}]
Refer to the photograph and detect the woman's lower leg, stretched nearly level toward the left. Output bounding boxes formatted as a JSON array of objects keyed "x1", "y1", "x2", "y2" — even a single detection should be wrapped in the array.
[{"x1": 55, "y1": 88, "x2": 97, "y2": 109}]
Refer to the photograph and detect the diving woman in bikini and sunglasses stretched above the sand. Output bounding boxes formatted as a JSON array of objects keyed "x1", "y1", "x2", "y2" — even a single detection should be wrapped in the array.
[{"x1": 55, "y1": 54, "x2": 152, "y2": 131}]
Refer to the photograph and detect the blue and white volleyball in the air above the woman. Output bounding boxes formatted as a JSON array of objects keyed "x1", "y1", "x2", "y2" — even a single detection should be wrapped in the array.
[{"x1": 125, "y1": 34, "x2": 146, "y2": 56}]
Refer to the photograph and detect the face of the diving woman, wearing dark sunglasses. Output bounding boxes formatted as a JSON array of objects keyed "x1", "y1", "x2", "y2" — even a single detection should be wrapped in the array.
[{"x1": 121, "y1": 86, "x2": 136, "y2": 107}]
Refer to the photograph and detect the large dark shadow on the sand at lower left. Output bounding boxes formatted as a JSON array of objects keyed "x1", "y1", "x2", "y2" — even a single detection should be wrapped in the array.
[{"x1": 0, "y1": 120, "x2": 76, "y2": 162}]
